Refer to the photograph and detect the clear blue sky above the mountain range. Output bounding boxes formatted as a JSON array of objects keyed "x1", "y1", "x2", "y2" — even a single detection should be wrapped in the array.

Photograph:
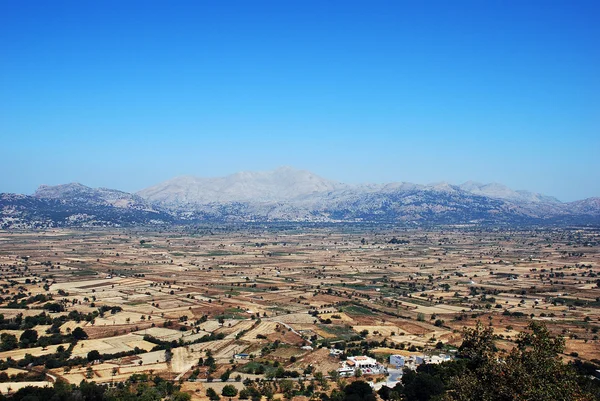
[{"x1": 0, "y1": 0, "x2": 600, "y2": 200}]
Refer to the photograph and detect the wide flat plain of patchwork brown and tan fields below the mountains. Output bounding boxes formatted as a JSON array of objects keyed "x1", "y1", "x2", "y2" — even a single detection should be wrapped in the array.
[{"x1": 0, "y1": 225, "x2": 600, "y2": 398}]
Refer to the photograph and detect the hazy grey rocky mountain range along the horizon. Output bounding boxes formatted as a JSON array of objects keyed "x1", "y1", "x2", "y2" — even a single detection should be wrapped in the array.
[{"x1": 0, "y1": 167, "x2": 600, "y2": 229}]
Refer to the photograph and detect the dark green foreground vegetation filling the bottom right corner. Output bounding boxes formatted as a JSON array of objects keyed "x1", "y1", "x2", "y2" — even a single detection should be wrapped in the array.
[{"x1": 379, "y1": 323, "x2": 600, "y2": 401}]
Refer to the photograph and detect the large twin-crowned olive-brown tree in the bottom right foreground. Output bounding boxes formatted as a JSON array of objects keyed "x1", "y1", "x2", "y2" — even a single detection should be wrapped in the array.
[{"x1": 444, "y1": 322, "x2": 594, "y2": 401}]
